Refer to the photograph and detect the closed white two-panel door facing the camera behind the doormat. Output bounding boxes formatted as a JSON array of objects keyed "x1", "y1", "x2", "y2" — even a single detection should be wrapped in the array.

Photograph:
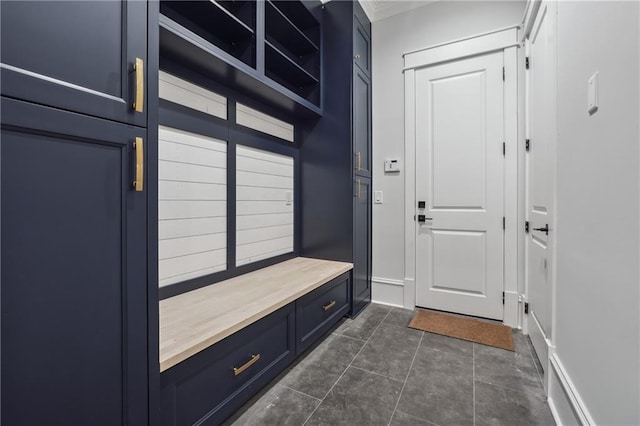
[{"x1": 415, "y1": 51, "x2": 504, "y2": 319}]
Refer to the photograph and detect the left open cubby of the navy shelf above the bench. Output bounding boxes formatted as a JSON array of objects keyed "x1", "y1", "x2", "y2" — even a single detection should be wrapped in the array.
[{"x1": 160, "y1": 0, "x2": 256, "y2": 67}]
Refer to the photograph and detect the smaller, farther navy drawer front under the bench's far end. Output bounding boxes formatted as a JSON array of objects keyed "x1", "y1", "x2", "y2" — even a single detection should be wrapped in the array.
[{"x1": 296, "y1": 272, "x2": 351, "y2": 354}]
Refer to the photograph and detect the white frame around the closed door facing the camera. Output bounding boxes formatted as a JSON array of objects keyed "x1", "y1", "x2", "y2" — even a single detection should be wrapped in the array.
[{"x1": 403, "y1": 26, "x2": 524, "y2": 327}]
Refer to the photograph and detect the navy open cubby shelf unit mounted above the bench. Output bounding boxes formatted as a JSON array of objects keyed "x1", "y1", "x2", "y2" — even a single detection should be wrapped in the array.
[{"x1": 160, "y1": 0, "x2": 322, "y2": 115}]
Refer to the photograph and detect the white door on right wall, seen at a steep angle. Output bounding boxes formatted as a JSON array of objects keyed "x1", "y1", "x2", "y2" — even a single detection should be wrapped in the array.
[{"x1": 526, "y1": 2, "x2": 555, "y2": 368}]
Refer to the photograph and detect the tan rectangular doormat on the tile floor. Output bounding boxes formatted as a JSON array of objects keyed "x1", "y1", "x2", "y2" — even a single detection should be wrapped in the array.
[{"x1": 409, "y1": 311, "x2": 514, "y2": 351}]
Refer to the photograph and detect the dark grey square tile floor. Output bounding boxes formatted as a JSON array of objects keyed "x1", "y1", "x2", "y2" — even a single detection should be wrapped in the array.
[{"x1": 228, "y1": 304, "x2": 555, "y2": 426}]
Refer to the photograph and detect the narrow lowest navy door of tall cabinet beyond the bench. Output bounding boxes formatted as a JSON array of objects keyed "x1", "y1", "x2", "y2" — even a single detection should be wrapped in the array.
[{"x1": 351, "y1": 178, "x2": 371, "y2": 316}]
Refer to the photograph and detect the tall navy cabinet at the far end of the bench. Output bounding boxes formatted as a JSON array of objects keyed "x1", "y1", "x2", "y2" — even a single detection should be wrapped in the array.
[{"x1": 300, "y1": 1, "x2": 372, "y2": 315}]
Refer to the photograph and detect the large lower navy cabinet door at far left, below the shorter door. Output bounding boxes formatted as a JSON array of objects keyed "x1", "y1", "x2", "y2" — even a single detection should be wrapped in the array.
[{"x1": 0, "y1": 98, "x2": 148, "y2": 426}]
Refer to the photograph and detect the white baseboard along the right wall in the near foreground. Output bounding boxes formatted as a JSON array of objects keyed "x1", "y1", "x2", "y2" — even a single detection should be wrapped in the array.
[{"x1": 549, "y1": 353, "x2": 596, "y2": 425}]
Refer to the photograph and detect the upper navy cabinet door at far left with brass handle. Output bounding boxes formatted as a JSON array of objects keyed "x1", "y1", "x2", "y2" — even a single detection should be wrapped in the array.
[{"x1": 0, "y1": 0, "x2": 147, "y2": 126}]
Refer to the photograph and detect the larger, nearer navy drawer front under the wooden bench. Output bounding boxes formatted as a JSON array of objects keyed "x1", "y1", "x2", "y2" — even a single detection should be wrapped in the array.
[{"x1": 162, "y1": 304, "x2": 295, "y2": 425}]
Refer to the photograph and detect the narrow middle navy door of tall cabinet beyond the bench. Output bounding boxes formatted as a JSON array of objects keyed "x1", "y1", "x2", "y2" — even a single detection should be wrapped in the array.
[{"x1": 353, "y1": 66, "x2": 372, "y2": 177}]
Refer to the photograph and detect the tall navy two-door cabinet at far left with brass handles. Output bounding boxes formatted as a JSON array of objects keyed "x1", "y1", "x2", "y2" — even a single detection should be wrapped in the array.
[{"x1": 0, "y1": 1, "x2": 152, "y2": 426}]
